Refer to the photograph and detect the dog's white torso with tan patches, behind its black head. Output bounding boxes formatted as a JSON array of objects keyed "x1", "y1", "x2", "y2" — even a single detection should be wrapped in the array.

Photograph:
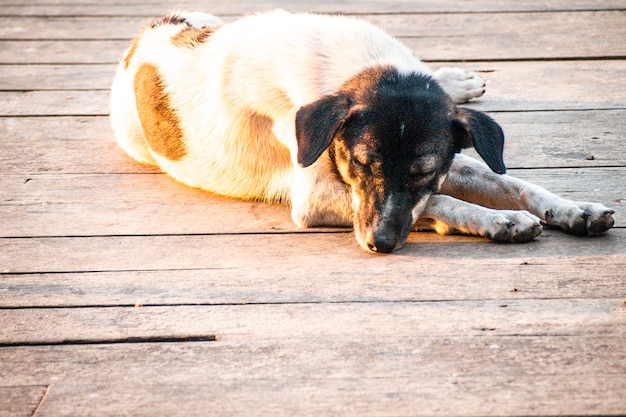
[{"x1": 111, "y1": 11, "x2": 428, "y2": 201}]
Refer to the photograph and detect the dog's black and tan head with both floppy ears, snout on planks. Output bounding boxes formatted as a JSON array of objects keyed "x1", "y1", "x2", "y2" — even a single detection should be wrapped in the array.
[{"x1": 296, "y1": 67, "x2": 505, "y2": 252}]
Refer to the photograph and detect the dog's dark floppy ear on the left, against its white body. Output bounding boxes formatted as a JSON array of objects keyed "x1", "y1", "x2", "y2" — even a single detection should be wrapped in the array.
[{"x1": 296, "y1": 94, "x2": 350, "y2": 167}]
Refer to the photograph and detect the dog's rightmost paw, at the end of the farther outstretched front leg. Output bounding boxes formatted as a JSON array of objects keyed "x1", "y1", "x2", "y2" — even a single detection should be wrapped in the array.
[{"x1": 545, "y1": 201, "x2": 615, "y2": 236}]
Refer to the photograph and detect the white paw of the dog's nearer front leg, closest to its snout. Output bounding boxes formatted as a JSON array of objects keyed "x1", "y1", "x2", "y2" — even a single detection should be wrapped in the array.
[{"x1": 485, "y1": 210, "x2": 543, "y2": 243}]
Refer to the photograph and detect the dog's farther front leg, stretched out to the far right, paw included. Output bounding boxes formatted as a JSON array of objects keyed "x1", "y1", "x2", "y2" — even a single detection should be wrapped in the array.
[{"x1": 441, "y1": 155, "x2": 615, "y2": 235}]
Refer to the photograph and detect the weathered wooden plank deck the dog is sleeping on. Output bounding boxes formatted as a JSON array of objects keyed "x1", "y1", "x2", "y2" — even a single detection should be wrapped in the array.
[{"x1": 0, "y1": 0, "x2": 626, "y2": 417}]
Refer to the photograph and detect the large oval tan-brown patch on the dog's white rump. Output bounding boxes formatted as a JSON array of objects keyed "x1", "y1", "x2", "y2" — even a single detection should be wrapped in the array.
[{"x1": 134, "y1": 64, "x2": 187, "y2": 161}]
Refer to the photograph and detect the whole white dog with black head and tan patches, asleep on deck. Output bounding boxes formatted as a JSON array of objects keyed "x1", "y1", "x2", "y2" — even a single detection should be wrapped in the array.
[{"x1": 110, "y1": 10, "x2": 614, "y2": 253}]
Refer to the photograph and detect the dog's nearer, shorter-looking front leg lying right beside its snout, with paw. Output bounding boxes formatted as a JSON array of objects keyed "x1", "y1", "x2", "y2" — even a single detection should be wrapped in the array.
[{"x1": 415, "y1": 194, "x2": 542, "y2": 242}]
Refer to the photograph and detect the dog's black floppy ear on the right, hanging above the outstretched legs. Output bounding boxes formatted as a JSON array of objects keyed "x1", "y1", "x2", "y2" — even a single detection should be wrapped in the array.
[{"x1": 454, "y1": 108, "x2": 506, "y2": 174}]
